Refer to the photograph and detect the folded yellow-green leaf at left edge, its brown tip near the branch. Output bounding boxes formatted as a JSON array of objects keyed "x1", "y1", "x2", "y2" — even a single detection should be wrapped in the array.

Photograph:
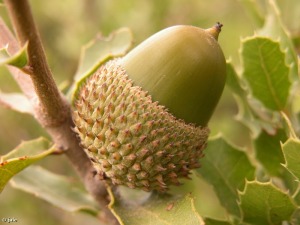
[{"x1": 0, "y1": 138, "x2": 55, "y2": 192}]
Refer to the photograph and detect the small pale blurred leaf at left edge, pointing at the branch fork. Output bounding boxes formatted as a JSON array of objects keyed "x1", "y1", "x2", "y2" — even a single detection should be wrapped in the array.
[{"x1": 0, "y1": 91, "x2": 34, "y2": 115}]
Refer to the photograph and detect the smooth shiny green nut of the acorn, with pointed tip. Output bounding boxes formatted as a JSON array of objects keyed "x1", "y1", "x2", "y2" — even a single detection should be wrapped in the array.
[{"x1": 122, "y1": 23, "x2": 226, "y2": 126}]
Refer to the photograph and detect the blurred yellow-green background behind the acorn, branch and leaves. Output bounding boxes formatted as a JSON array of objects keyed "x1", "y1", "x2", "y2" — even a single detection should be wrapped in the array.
[{"x1": 0, "y1": 0, "x2": 300, "y2": 225}]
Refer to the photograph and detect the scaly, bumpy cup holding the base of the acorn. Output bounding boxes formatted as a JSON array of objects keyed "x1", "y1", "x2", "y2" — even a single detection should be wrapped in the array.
[{"x1": 73, "y1": 59, "x2": 209, "y2": 192}]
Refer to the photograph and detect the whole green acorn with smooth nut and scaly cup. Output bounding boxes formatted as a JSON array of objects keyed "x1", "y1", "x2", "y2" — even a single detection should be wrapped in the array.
[{"x1": 73, "y1": 23, "x2": 226, "y2": 192}]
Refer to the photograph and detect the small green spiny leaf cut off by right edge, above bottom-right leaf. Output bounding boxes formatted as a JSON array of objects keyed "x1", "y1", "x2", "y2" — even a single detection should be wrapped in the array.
[{"x1": 281, "y1": 138, "x2": 300, "y2": 181}]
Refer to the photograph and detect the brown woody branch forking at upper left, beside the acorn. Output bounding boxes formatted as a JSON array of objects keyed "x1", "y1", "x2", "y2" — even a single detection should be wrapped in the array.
[{"x1": 0, "y1": 0, "x2": 118, "y2": 224}]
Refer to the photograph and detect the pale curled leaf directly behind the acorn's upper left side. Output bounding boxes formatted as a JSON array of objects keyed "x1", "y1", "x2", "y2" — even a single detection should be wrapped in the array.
[{"x1": 68, "y1": 28, "x2": 132, "y2": 102}]
